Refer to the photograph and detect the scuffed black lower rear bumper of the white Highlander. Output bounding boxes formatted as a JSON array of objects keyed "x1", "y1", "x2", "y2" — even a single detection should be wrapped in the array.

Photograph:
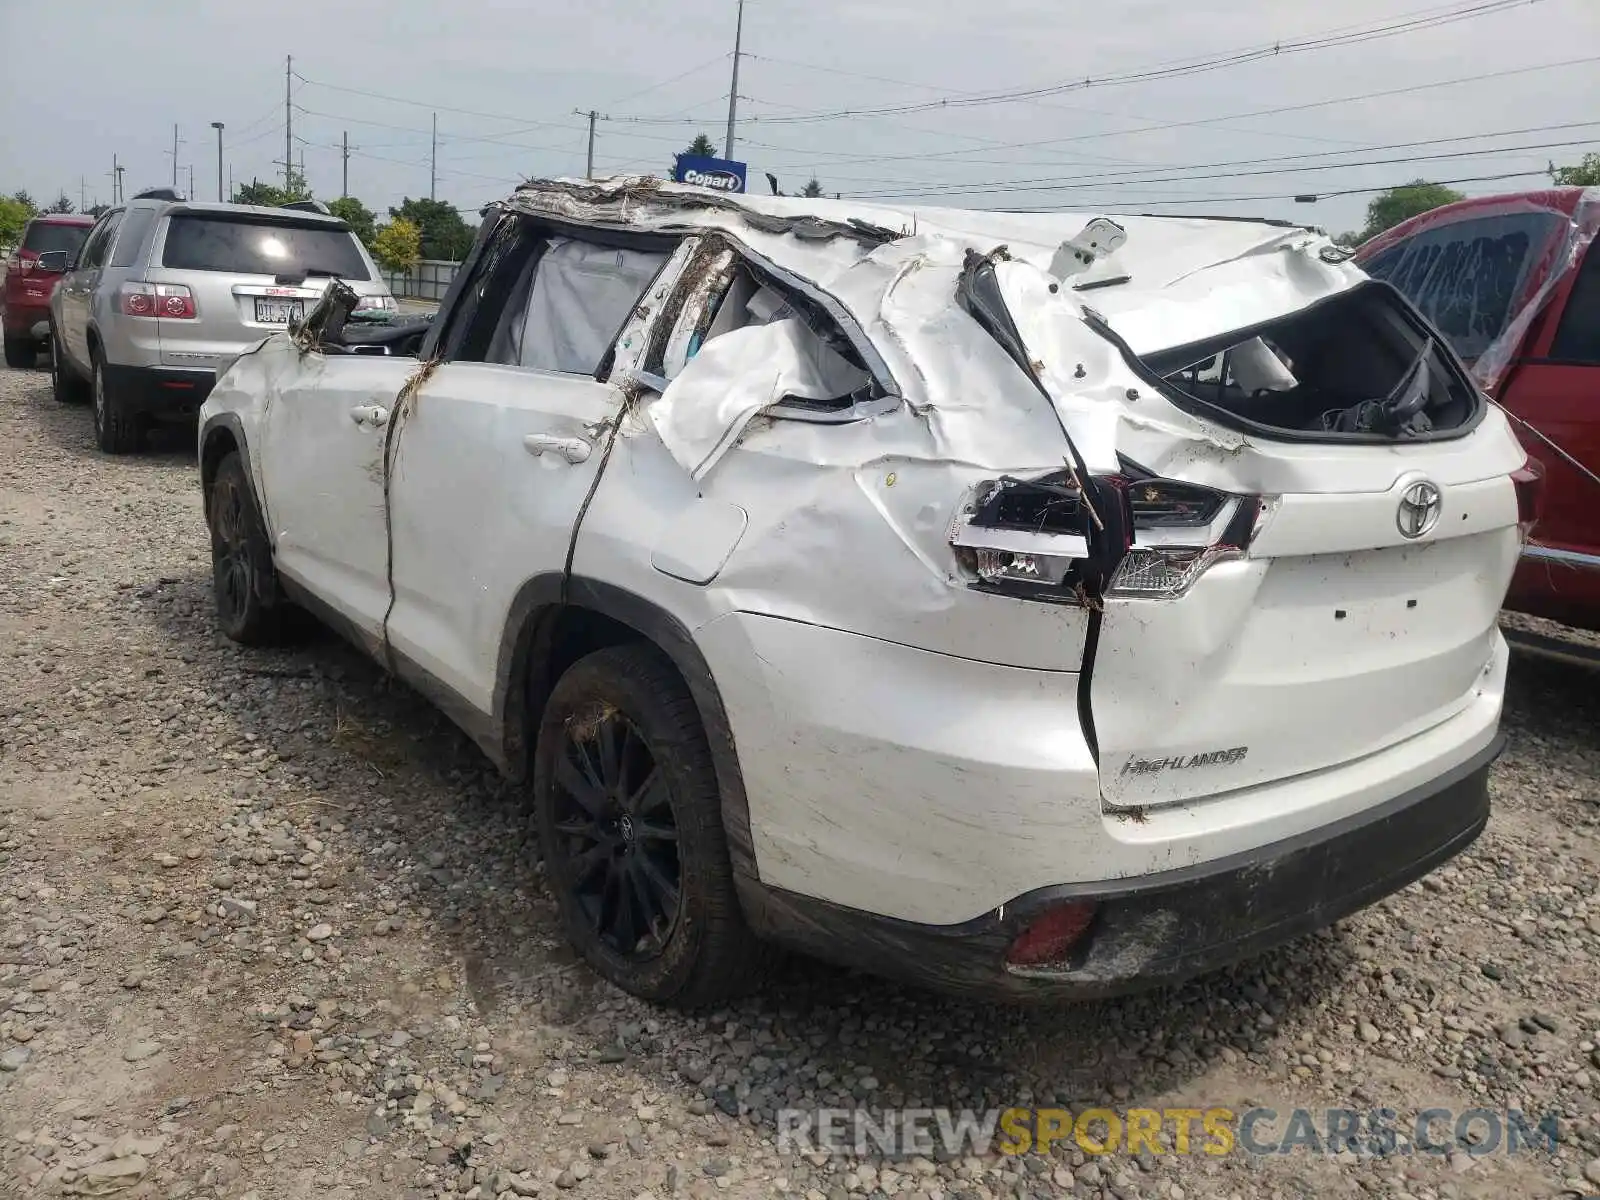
[{"x1": 741, "y1": 738, "x2": 1504, "y2": 1000}]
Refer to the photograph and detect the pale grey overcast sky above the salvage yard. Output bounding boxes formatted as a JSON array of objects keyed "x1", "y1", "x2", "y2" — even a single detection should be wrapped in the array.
[{"x1": 0, "y1": 0, "x2": 1600, "y2": 238}]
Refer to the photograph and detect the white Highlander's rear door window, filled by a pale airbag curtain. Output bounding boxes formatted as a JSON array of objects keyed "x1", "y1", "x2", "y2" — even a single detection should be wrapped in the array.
[{"x1": 486, "y1": 237, "x2": 670, "y2": 376}]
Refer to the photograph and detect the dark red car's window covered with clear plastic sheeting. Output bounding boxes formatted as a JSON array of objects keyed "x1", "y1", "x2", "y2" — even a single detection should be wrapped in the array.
[{"x1": 1366, "y1": 213, "x2": 1562, "y2": 362}]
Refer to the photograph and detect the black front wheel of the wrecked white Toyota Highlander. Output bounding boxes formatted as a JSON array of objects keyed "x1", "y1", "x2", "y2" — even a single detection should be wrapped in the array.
[{"x1": 205, "y1": 450, "x2": 288, "y2": 646}]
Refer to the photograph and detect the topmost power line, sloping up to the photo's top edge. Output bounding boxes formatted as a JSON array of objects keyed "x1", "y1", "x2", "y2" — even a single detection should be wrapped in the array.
[{"x1": 723, "y1": 0, "x2": 1539, "y2": 125}]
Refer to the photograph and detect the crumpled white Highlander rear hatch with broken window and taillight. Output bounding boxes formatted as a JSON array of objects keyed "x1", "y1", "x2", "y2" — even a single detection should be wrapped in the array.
[{"x1": 958, "y1": 227, "x2": 1525, "y2": 808}]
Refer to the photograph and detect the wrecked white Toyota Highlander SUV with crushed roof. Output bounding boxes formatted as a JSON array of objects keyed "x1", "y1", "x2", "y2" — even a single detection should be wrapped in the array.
[{"x1": 200, "y1": 179, "x2": 1538, "y2": 1003}]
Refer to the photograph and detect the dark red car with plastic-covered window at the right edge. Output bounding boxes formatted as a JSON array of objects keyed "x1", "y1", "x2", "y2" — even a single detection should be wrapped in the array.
[{"x1": 1355, "y1": 187, "x2": 1600, "y2": 629}]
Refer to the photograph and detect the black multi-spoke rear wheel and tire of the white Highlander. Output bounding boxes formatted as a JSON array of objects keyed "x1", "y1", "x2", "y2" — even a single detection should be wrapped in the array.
[{"x1": 533, "y1": 643, "x2": 765, "y2": 1008}]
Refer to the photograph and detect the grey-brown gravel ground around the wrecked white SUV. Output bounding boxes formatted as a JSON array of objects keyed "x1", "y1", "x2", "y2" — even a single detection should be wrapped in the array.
[{"x1": 0, "y1": 371, "x2": 1600, "y2": 1200}]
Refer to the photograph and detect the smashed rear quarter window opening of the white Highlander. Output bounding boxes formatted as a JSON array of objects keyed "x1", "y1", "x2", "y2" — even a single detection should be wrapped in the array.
[{"x1": 646, "y1": 251, "x2": 880, "y2": 413}]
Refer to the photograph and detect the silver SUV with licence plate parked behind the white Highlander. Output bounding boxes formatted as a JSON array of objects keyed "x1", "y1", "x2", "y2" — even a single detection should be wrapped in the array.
[{"x1": 50, "y1": 194, "x2": 395, "y2": 454}]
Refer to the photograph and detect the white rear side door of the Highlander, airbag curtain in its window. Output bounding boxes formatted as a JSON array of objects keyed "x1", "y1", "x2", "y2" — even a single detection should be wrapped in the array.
[{"x1": 387, "y1": 214, "x2": 683, "y2": 712}]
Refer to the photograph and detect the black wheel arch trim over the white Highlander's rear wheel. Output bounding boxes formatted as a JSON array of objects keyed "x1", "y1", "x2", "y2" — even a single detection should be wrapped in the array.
[{"x1": 494, "y1": 571, "x2": 757, "y2": 880}]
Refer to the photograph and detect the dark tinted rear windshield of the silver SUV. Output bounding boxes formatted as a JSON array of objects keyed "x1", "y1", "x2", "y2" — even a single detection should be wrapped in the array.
[{"x1": 162, "y1": 213, "x2": 371, "y2": 280}]
